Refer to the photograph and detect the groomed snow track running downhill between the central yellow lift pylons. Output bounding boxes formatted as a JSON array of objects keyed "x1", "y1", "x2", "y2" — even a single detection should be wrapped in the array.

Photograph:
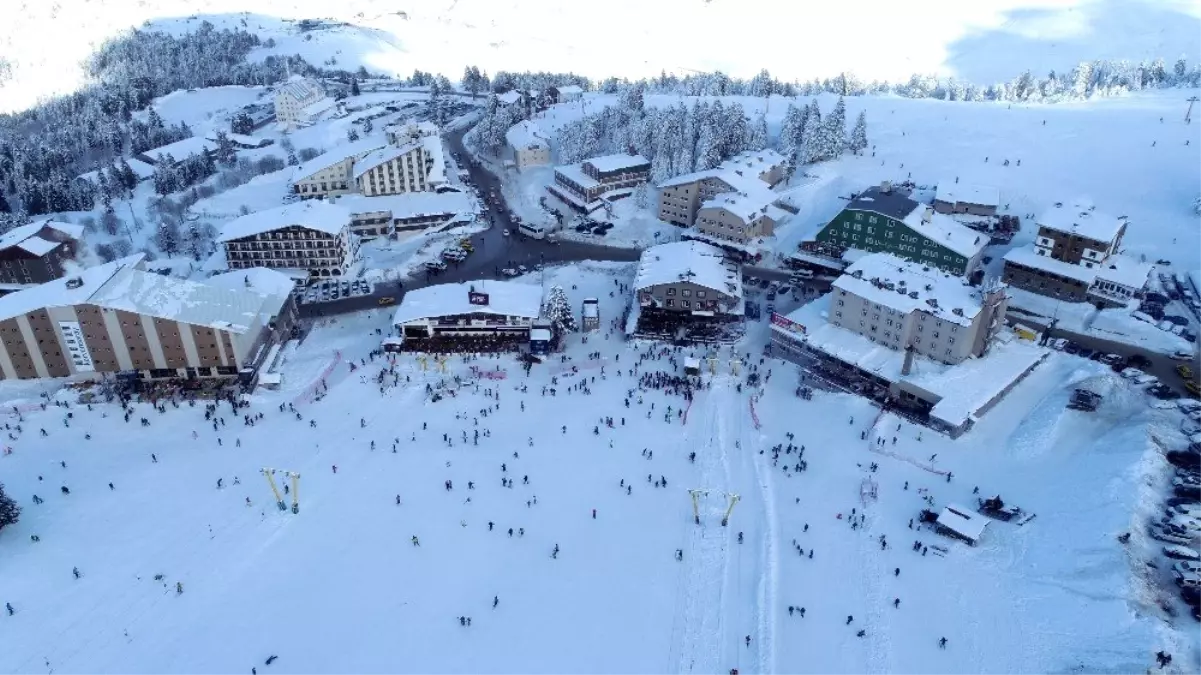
[{"x1": 671, "y1": 382, "x2": 730, "y2": 675}]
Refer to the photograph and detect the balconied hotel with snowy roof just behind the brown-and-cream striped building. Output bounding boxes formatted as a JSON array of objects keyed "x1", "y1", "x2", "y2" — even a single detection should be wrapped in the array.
[{"x1": 217, "y1": 202, "x2": 359, "y2": 277}]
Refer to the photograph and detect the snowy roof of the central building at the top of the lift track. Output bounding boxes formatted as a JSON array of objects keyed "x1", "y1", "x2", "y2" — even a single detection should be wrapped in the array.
[{"x1": 634, "y1": 241, "x2": 742, "y2": 298}]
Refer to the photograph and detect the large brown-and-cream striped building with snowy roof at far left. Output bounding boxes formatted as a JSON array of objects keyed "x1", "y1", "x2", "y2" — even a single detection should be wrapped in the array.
[{"x1": 0, "y1": 256, "x2": 288, "y2": 380}]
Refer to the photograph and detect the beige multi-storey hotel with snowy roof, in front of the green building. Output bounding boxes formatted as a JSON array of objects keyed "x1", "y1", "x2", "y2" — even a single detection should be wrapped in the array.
[{"x1": 829, "y1": 253, "x2": 1009, "y2": 364}]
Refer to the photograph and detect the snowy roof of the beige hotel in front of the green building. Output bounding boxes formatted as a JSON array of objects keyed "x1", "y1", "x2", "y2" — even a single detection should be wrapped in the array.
[{"x1": 833, "y1": 253, "x2": 980, "y2": 325}]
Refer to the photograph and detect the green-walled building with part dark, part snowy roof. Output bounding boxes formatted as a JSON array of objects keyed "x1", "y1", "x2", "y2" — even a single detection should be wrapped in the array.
[{"x1": 815, "y1": 186, "x2": 988, "y2": 275}]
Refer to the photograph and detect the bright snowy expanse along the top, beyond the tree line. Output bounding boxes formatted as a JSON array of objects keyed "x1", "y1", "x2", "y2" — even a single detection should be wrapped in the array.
[{"x1": 7, "y1": 0, "x2": 1201, "y2": 110}]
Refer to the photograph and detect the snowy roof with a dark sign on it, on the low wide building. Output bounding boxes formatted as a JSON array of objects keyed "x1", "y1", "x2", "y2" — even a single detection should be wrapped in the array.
[{"x1": 391, "y1": 281, "x2": 542, "y2": 325}]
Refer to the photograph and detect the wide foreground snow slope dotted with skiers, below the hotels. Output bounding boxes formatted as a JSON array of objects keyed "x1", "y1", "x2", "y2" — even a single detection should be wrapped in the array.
[{"x1": 0, "y1": 264, "x2": 1181, "y2": 675}]
